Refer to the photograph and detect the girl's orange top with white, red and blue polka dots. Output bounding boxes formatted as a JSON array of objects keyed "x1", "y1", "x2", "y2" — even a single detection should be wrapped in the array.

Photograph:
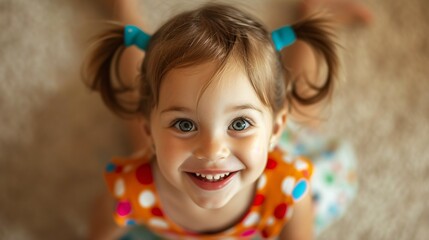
[{"x1": 105, "y1": 149, "x2": 313, "y2": 239}]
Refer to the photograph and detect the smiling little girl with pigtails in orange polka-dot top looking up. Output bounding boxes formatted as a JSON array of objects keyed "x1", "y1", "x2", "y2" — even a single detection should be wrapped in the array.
[{"x1": 85, "y1": 4, "x2": 348, "y2": 240}]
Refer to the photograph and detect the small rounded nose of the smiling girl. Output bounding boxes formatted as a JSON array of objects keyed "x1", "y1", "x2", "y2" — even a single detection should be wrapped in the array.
[{"x1": 193, "y1": 136, "x2": 230, "y2": 161}]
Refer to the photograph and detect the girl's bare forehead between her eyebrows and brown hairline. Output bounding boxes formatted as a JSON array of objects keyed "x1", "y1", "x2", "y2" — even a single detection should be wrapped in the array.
[{"x1": 159, "y1": 62, "x2": 260, "y2": 108}]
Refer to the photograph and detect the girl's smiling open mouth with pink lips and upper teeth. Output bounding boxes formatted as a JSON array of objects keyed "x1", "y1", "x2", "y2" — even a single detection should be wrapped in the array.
[{"x1": 187, "y1": 172, "x2": 237, "y2": 191}]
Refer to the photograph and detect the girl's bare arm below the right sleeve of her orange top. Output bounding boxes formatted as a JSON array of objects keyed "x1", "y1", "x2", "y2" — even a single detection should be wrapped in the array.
[{"x1": 279, "y1": 188, "x2": 314, "y2": 240}]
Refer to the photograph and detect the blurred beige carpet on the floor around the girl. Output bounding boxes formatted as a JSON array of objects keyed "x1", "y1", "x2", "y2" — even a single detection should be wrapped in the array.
[{"x1": 0, "y1": 0, "x2": 429, "y2": 240}]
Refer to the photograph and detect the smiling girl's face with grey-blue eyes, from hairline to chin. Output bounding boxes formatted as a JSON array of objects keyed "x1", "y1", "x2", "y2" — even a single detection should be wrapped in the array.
[{"x1": 150, "y1": 63, "x2": 284, "y2": 209}]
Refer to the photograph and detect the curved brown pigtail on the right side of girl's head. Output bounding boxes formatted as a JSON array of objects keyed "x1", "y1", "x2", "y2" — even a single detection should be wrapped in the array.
[{"x1": 288, "y1": 18, "x2": 339, "y2": 106}]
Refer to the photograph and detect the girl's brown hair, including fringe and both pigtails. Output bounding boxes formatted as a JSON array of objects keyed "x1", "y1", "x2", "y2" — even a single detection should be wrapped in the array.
[{"x1": 83, "y1": 4, "x2": 338, "y2": 118}]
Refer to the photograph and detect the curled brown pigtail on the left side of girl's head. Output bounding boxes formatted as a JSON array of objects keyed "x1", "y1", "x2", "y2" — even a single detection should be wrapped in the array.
[{"x1": 82, "y1": 23, "x2": 138, "y2": 117}]
